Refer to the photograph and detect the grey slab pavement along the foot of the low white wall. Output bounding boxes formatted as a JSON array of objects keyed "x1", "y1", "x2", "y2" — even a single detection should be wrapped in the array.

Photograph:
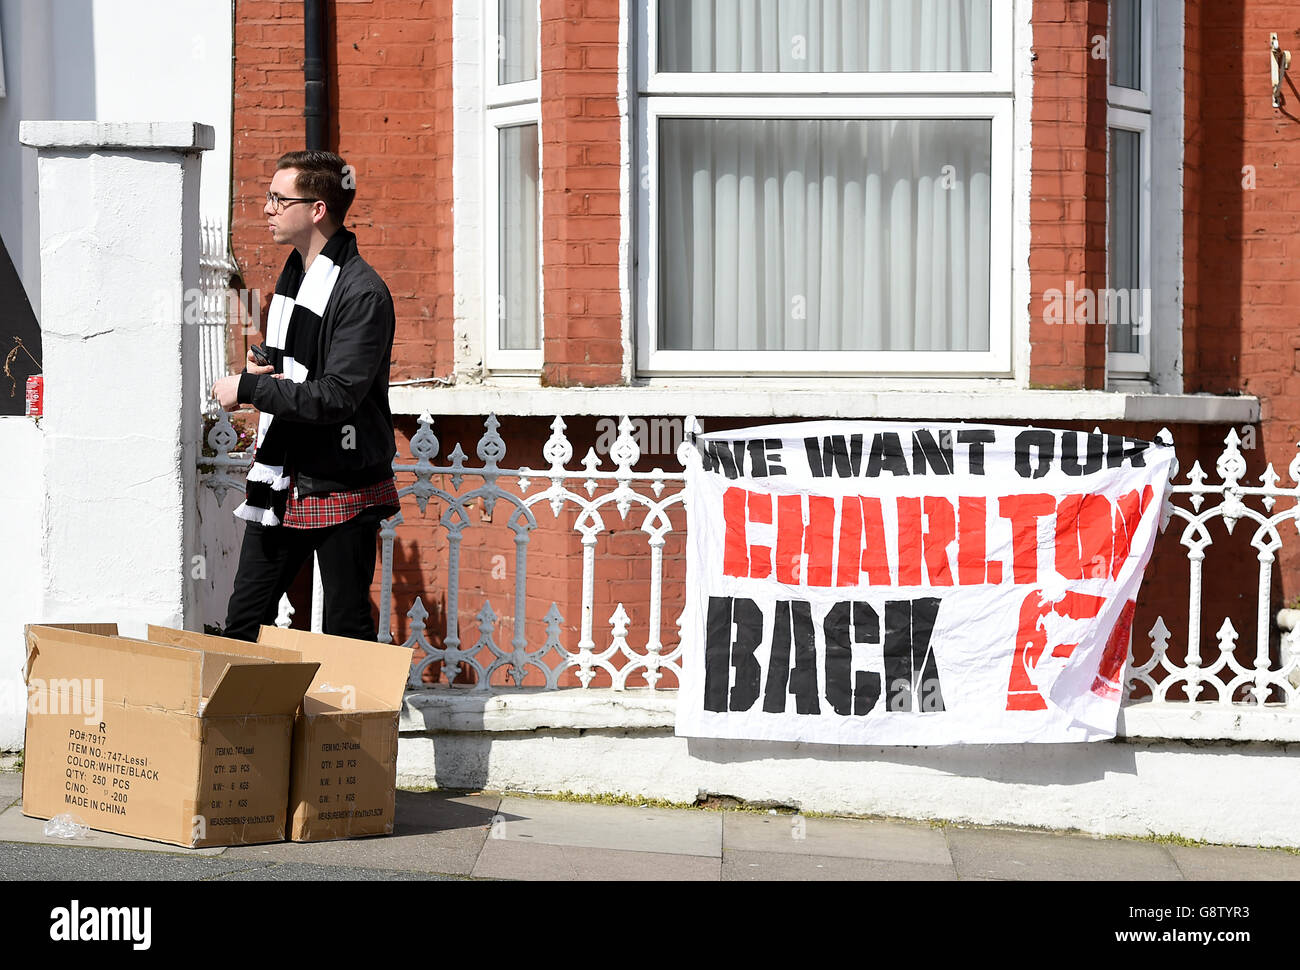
[{"x1": 0, "y1": 772, "x2": 1300, "y2": 882}]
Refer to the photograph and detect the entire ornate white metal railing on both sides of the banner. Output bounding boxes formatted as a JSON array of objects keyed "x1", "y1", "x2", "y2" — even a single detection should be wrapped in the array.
[{"x1": 202, "y1": 415, "x2": 1300, "y2": 711}]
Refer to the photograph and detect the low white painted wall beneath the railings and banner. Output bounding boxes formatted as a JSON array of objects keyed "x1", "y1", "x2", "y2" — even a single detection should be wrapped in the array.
[{"x1": 398, "y1": 690, "x2": 1300, "y2": 846}]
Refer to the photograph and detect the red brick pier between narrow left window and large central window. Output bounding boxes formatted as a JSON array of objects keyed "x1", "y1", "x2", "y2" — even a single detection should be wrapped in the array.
[{"x1": 541, "y1": 0, "x2": 623, "y2": 386}]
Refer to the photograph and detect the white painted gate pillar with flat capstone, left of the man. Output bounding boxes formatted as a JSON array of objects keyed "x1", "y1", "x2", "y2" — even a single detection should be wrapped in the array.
[{"x1": 20, "y1": 121, "x2": 213, "y2": 636}]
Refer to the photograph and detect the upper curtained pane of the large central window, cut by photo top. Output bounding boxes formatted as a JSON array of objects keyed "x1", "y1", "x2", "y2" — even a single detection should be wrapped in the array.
[{"x1": 658, "y1": 0, "x2": 993, "y2": 74}]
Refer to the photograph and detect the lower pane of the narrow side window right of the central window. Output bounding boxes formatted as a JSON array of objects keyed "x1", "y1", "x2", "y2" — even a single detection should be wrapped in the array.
[{"x1": 1099, "y1": 127, "x2": 1151, "y2": 354}]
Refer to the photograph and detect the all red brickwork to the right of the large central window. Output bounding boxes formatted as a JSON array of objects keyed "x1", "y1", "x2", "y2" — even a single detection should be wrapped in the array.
[{"x1": 1030, "y1": 0, "x2": 1300, "y2": 657}]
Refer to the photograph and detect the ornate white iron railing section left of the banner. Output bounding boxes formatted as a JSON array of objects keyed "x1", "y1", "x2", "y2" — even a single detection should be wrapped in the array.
[{"x1": 200, "y1": 415, "x2": 688, "y2": 692}]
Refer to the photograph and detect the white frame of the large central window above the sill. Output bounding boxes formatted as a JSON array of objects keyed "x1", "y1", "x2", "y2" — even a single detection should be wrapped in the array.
[{"x1": 634, "y1": 0, "x2": 1017, "y2": 378}]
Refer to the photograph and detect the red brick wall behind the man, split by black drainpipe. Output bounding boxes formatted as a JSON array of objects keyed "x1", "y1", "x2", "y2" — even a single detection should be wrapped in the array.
[{"x1": 233, "y1": 0, "x2": 454, "y2": 380}]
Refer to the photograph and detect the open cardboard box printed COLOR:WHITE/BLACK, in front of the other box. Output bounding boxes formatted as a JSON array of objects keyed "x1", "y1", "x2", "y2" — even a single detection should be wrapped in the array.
[{"x1": 22, "y1": 623, "x2": 319, "y2": 848}]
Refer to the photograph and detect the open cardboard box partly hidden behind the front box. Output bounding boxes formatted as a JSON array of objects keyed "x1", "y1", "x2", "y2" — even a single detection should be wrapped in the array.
[{"x1": 148, "y1": 627, "x2": 415, "y2": 843}]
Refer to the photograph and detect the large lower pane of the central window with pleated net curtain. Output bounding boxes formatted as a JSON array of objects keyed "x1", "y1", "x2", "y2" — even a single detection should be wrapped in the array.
[{"x1": 659, "y1": 118, "x2": 992, "y2": 351}]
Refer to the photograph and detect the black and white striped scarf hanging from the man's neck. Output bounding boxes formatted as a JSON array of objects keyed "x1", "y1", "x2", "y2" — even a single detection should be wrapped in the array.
[{"x1": 235, "y1": 229, "x2": 356, "y2": 525}]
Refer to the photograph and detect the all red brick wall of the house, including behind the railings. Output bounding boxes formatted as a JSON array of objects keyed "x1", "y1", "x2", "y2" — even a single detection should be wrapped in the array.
[{"x1": 234, "y1": 0, "x2": 1300, "y2": 683}]
